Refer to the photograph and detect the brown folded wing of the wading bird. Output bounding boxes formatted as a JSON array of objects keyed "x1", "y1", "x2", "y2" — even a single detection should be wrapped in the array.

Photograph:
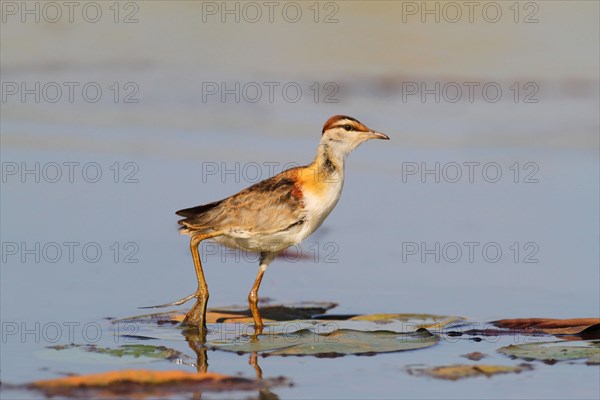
[{"x1": 177, "y1": 169, "x2": 304, "y2": 233}]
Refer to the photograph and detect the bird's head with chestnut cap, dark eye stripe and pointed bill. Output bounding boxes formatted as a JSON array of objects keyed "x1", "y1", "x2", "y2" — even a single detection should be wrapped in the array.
[{"x1": 321, "y1": 115, "x2": 390, "y2": 155}]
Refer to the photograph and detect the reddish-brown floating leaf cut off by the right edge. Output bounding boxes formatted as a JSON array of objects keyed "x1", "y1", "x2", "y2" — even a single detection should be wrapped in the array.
[{"x1": 492, "y1": 318, "x2": 600, "y2": 335}]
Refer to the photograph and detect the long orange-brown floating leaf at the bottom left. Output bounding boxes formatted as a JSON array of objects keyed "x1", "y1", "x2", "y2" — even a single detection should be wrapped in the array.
[{"x1": 27, "y1": 370, "x2": 284, "y2": 398}]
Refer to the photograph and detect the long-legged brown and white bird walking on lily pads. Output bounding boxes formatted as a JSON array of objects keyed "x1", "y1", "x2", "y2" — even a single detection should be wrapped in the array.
[{"x1": 148, "y1": 115, "x2": 390, "y2": 332}]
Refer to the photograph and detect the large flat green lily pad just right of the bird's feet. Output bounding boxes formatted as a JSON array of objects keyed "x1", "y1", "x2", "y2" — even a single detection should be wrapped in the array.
[{"x1": 207, "y1": 329, "x2": 438, "y2": 357}]
